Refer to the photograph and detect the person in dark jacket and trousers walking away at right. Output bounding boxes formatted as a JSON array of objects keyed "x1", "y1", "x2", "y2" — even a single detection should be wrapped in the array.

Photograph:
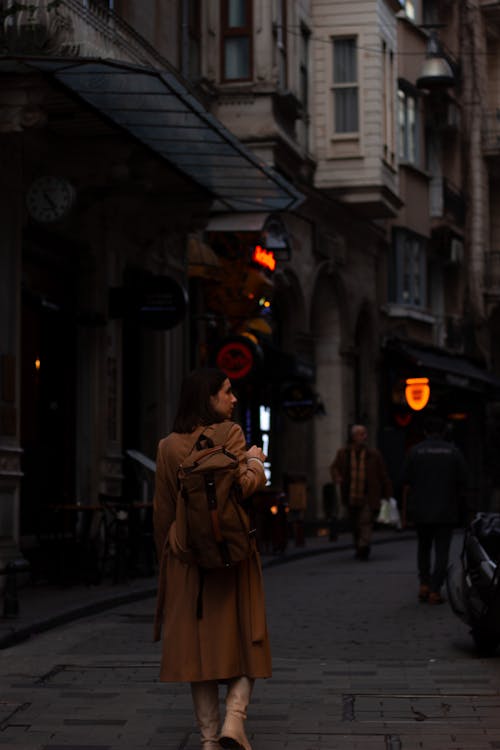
[{"x1": 401, "y1": 416, "x2": 468, "y2": 604}]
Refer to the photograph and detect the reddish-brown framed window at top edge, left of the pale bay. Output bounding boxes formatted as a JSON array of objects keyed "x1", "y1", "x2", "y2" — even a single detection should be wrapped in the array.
[{"x1": 221, "y1": 0, "x2": 252, "y2": 81}]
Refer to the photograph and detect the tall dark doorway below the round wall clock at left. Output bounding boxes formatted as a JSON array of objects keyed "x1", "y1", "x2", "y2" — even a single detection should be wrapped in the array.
[{"x1": 20, "y1": 268, "x2": 76, "y2": 536}]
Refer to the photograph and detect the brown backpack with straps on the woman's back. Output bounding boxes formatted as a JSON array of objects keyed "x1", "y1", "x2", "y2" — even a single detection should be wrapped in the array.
[{"x1": 176, "y1": 422, "x2": 255, "y2": 570}]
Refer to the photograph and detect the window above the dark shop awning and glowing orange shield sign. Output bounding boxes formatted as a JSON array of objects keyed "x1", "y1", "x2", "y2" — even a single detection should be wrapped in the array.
[{"x1": 389, "y1": 229, "x2": 427, "y2": 307}]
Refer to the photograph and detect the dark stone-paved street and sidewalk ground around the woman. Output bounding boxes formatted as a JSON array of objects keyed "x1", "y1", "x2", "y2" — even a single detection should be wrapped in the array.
[{"x1": 0, "y1": 532, "x2": 500, "y2": 750}]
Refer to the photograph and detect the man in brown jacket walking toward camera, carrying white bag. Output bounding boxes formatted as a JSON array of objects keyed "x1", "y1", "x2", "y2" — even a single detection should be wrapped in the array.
[{"x1": 330, "y1": 424, "x2": 392, "y2": 560}]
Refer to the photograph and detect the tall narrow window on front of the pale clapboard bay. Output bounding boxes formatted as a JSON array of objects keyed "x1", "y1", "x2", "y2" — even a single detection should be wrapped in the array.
[{"x1": 332, "y1": 38, "x2": 359, "y2": 135}]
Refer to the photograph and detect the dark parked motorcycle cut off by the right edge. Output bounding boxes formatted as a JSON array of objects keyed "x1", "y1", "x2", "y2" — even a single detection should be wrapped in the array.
[{"x1": 446, "y1": 513, "x2": 500, "y2": 655}]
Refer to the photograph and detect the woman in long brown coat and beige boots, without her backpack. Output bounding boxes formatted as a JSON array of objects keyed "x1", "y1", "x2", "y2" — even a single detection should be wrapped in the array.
[{"x1": 154, "y1": 368, "x2": 271, "y2": 750}]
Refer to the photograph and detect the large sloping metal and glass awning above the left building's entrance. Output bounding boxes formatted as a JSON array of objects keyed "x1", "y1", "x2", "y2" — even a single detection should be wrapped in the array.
[{"x1": 2, "y1": 57, "x2": 304, "y2": 212}]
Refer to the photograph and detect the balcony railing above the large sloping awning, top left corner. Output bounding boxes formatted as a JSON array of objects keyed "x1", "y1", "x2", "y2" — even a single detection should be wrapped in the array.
[{"x1": 0, "y1": 0, "x2": 168, "y2": 67}]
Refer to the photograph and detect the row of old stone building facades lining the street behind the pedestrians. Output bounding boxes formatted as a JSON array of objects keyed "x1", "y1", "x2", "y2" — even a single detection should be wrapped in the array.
[{"x1": 0, "y1": 0, "x2": 500, "y2": 576}]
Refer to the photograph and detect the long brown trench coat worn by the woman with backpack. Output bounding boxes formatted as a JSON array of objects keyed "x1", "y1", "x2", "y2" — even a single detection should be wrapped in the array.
[{"x1": 154, "y1": 424, "x2": 271, "y2": 682}]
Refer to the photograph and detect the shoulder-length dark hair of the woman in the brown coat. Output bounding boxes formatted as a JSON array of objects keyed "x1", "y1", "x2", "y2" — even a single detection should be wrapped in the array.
[{"x1": 172, "y1": 367, "x2": 227, "y2": 432}]
